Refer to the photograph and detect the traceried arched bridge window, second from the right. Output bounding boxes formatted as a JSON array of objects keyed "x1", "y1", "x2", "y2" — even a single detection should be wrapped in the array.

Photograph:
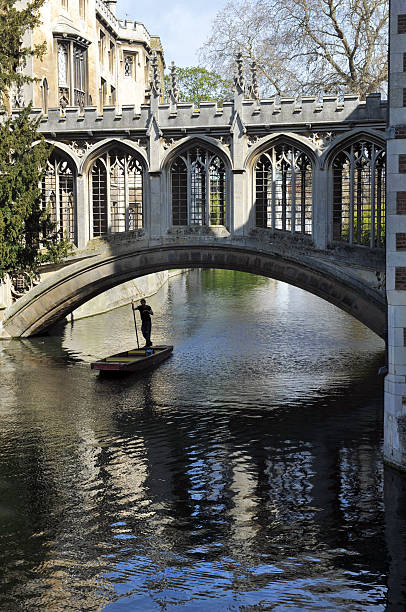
[{"x1": 255, "y1": 144, "x2": 312, "y2": 234}]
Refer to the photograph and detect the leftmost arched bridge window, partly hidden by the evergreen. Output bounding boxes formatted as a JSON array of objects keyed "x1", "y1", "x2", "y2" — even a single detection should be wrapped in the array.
[{"x1": 41, "y1": 153, "x2": 76, "y2": 243}]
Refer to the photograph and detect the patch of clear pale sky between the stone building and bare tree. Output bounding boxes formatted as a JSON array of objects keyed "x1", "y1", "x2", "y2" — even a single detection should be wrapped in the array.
[{"x1": 117, "y1": 0, "x2": 220, "y2": 66}]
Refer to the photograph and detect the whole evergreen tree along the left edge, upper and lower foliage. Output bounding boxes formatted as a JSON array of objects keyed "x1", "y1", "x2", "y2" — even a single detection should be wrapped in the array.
[{"x1": 0, "y1": 0, "x2": 71, "y2": 279}]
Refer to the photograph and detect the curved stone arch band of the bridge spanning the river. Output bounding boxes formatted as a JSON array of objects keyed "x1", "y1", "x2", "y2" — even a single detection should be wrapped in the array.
[{"x1": 0, "y1": 243, "x2": 386, "y2": 338}]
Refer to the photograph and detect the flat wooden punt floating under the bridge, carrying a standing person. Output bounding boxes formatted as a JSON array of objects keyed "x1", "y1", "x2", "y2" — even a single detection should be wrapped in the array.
[{"x1": 91, "y1": 345, "x2": 173, "y2": 372}]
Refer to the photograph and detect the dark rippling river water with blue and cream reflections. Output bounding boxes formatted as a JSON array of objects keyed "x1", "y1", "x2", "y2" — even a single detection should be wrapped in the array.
[{"x1": 0, "y1": 271, "x2": 406, "y2": 612}]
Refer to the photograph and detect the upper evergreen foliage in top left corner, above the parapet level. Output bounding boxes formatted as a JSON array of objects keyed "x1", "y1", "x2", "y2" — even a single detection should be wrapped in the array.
[{"x1": 0, "y1": 0, "x2": 46, "y2": 103}]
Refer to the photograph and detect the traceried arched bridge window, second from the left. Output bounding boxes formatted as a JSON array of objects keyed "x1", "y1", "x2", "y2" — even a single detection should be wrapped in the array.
[{"x1": 90, "y1": 149, "x2": 143, "y2": 237}]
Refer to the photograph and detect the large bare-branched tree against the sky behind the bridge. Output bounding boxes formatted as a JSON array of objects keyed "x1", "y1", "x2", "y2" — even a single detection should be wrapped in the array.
[{"x1": 200, "y1": 0, "x2": 389, "y2": 98}]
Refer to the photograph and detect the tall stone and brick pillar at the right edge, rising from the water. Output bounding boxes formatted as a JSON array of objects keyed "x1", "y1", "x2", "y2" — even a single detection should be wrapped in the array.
[{"x1": 384, "y1": 0, "x2": 406, "y2": 469}]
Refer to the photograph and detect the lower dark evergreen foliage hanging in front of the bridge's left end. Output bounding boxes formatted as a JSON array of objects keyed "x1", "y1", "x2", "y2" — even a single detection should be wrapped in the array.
[{"x1": 0, "y1": 107, "x2": 71, "y2": 277}]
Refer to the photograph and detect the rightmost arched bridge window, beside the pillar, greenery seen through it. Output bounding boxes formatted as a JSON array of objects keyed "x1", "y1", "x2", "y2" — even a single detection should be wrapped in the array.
[{"x1": 333, "y1": 141, "x2": 385, "y2": 248}]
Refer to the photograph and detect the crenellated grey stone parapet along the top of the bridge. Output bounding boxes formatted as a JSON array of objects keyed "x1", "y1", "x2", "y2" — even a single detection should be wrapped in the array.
[{"x1": 0, "y1": 94, "x2": 388, "y2": 135}]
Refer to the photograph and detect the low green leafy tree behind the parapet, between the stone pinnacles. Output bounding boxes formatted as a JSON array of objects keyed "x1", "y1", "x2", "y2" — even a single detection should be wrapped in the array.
[{"x1": 165, "y1": 66, "x2": 233, "y2": 106}]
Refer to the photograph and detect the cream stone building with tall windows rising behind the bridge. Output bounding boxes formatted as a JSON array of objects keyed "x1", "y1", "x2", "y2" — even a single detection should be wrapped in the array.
[{"x1": 11, "y1": 0, "x2": 164, "y2": 115}]
